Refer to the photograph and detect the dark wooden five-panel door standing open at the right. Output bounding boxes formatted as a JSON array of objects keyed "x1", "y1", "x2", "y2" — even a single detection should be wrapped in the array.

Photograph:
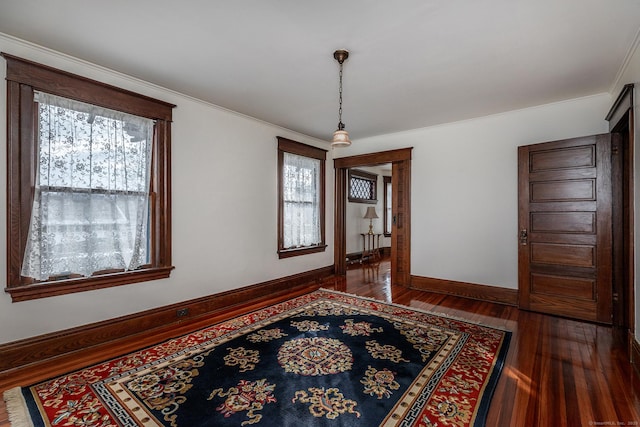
[{"x1": 518, "y1": 134, "x2": 612, "y2": 324}]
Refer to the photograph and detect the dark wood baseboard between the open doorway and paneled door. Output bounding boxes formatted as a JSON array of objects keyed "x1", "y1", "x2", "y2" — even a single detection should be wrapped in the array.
[{"x1": 411, "y1": 276, "x2": 518, "y2": 306}]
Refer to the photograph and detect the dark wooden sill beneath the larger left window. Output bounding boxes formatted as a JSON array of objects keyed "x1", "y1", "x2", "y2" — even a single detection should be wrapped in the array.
[{"x1": 4, "y1": 267, "x2": 174, "y2": 302}]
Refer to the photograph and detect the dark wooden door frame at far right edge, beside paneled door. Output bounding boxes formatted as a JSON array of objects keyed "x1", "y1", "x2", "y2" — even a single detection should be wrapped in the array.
[{"x1": 605, "y1": 84, "x2": 635, "y2": 332}]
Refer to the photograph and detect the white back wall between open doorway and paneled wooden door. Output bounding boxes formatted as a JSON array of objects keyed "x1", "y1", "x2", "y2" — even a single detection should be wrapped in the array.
[{"x1": 335, "y1": 94, "x2": 608, "y2": 289}]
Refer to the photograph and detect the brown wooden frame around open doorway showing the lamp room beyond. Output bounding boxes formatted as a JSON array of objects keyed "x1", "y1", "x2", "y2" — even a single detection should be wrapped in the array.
[{"x1": 334, "y1": 148, "x2": 412, "y2": 287}]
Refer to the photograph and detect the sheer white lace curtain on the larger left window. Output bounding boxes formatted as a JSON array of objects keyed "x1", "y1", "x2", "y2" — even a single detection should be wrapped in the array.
[{"x1": 22, "y1": 93, "x2": 153, "y2": 280}]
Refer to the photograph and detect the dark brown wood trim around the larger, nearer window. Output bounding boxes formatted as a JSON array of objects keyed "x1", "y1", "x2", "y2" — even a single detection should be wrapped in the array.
[{"x1": 1, "y1": 52, "x2": 175, "y2": 302}]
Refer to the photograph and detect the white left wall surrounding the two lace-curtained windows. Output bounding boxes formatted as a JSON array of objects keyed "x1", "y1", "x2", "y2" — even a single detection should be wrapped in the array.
[{"x1": 0, "y1": 34, "x2": 334, "y2": 343}]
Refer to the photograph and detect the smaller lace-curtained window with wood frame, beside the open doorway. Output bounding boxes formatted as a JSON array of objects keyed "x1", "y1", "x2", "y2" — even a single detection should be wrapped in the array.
[{"x1": 278, "y1": 137, "x2": 327, "y2": 258}]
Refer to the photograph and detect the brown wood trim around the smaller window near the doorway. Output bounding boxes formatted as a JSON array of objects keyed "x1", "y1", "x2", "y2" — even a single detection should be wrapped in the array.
[{"x1": 277, "y1": 136, "x2": 327, "y2": 259}]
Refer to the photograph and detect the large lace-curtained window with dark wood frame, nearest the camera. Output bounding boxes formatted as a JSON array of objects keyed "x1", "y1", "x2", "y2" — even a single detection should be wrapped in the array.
[{"x1": 2, "y1": 54, "x2": 174, "y2": 301}]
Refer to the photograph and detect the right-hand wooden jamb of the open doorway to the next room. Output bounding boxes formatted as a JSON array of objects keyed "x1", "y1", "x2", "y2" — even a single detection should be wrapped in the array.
[{"x1": 391, "y1": 161, "x2": 411, "y2": 286}]
